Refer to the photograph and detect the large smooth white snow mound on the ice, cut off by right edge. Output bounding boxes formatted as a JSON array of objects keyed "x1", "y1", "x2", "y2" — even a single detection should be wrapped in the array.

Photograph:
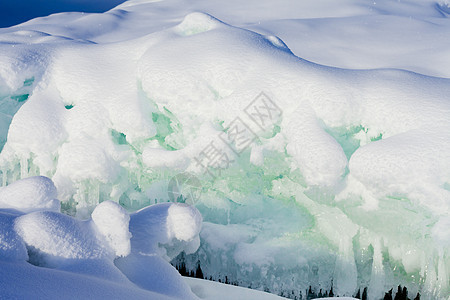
[{"x1": 349, "y1": 123, "x2": 450, "y2": 215}]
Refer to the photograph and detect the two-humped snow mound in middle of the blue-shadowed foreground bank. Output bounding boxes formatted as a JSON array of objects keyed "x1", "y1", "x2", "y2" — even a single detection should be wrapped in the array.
[{"x1": 14, "y1": 201, "x2": 135, "y2": 267}]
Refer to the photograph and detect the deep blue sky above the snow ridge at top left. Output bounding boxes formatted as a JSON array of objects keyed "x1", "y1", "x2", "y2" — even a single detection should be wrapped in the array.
[{"x1": 0, "y1": 0, "x2": 125, "y2": 27}]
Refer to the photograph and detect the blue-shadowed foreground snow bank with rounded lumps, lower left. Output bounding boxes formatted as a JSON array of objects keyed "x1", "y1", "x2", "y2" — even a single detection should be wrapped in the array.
[{"x1": 0, "y1": 177, "x2": 201, "y2": 299}]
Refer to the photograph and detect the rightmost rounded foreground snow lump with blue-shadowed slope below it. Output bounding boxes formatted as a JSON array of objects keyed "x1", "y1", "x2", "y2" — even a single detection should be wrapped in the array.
[{"x1": 115, "y1": 203, "x2": 202, "y2": 299}]
